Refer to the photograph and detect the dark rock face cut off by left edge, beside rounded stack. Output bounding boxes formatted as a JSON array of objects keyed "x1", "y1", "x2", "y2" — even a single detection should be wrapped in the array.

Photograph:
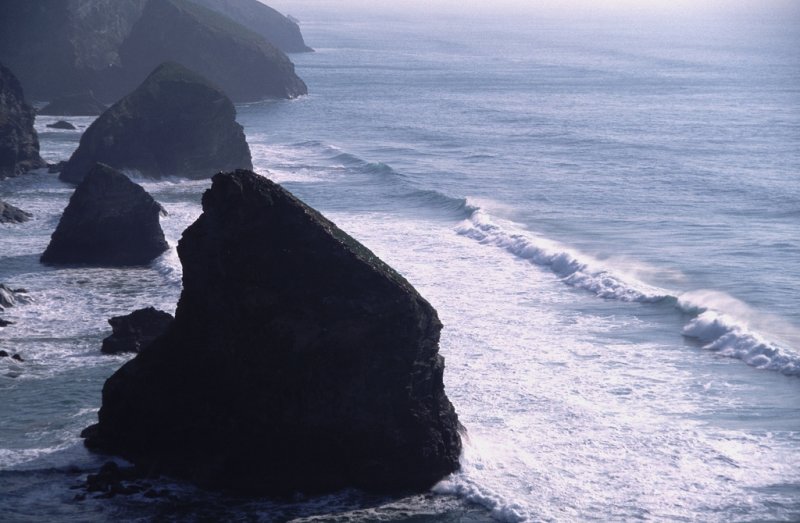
[{"x1": 0, "y1": 62, "x2": 47, "y2": 180}]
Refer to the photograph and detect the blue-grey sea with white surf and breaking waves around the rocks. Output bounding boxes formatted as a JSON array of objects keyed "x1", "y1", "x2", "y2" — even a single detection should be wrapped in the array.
[{"x1": 0, "y1": 8, "x2": 800, "y2": 522}]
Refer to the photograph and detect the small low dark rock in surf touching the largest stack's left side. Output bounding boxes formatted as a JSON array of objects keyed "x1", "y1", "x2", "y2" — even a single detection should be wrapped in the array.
[{"x1": 100, "y1": 307, "x2": 174, "y2": 354}]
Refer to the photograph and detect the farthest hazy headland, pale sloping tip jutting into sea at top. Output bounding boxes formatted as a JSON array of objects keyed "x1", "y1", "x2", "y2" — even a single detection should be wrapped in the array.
[{"x1": 191, "y1": 0, "x2": 313, "y2": 53}]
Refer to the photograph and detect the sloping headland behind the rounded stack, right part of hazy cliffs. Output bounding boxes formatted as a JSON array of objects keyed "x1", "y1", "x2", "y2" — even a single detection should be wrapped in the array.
[{"x1": 119, "y1": 0, "x2": 307, "y2": 102}]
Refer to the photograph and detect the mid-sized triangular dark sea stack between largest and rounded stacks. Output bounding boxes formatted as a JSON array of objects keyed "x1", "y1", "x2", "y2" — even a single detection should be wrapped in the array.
[{"x1": 41, "y1": 164, "x2": 169, "y2": 266}]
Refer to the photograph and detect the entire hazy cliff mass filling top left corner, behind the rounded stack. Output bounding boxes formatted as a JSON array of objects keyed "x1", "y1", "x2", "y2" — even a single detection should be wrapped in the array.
[{"x1": 0, "y1": 0, "x2": 305, "y2": 101}]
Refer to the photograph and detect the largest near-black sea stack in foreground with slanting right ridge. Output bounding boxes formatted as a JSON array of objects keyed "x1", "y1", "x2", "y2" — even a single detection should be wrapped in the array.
[{"x1": 84, "y1": 171, "x2": 461, "y2": 493}]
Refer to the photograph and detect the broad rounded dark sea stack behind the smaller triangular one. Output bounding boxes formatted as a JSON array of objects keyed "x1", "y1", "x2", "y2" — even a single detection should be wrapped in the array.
[{"x1": 59, "y1": 63, "x2": 252, "y2": 183}]
